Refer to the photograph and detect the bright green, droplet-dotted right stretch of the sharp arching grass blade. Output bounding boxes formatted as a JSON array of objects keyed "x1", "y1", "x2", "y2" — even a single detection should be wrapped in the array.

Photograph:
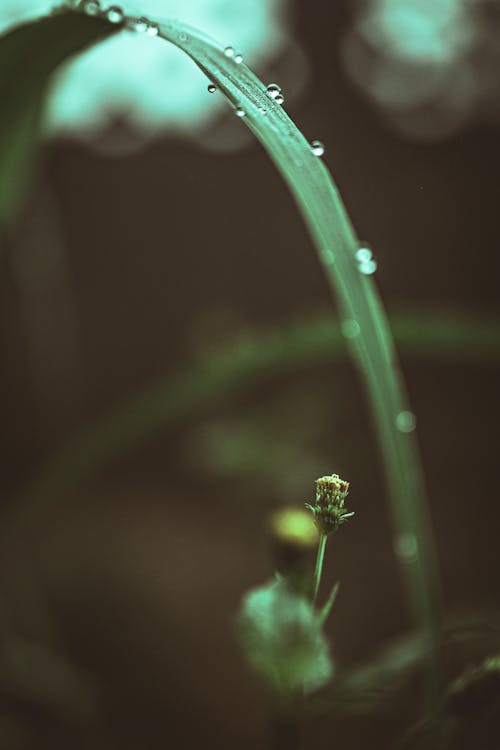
[{"x1": 140, "y1": 19, "x2": 442, "y2": 706}]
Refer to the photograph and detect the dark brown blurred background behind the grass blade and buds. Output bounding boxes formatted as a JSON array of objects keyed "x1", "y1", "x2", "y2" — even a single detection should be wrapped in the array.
[{"x1": 0, "y1": 0, "x2": 500, "y2": 750}]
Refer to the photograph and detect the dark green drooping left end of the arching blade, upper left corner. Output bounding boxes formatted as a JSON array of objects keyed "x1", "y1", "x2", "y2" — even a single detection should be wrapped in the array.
[{"x1": 0, "y1": 12, "x2": 120, "y2": 234}]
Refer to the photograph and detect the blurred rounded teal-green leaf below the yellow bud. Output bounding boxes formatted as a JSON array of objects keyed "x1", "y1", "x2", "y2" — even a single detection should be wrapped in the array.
[{"x1": 237, "y1": 578, "x2": 333, "y2": 695}]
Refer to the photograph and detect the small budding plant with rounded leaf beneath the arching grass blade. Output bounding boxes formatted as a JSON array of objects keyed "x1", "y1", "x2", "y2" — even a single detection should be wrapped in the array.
[{"x1": 237, "y1": 474, "x2": 354, "y2": 748}]
